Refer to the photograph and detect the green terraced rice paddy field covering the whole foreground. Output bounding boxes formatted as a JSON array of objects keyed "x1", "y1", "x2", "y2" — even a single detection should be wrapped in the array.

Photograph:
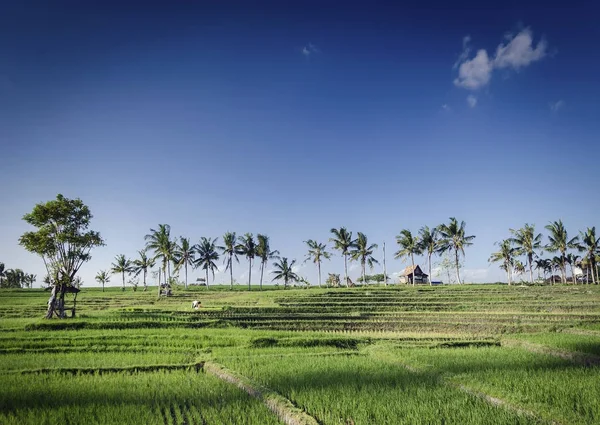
[{"x1": 0, "y1": 285, "x2": 600, "y2": 425}]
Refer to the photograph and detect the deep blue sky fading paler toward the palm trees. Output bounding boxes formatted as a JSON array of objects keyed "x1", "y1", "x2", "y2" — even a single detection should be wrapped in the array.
[{"x1": 0, "y1": 1, "x2": 600, "y2": 286}]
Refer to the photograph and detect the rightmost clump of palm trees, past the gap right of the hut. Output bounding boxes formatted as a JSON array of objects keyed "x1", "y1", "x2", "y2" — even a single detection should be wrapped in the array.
[{"x1": 489, "y1": 220, "x2": 600, "y2": 285}]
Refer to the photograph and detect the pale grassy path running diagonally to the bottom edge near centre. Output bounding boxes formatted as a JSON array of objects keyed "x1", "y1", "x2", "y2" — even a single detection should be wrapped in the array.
[{"x1": 204, "y1": 362, "x2": 319, "y2": 425}]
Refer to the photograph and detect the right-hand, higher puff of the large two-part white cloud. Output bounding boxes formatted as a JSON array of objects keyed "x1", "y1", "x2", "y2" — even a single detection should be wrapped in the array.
[{"x1": 494, "y1": 28, "x2": 548, "y2": 70}]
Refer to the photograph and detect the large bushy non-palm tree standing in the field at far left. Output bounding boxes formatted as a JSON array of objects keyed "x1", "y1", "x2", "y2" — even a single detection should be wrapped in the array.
[{"x1": 19, "y1": 194, "x2": 104, "y2": 318}]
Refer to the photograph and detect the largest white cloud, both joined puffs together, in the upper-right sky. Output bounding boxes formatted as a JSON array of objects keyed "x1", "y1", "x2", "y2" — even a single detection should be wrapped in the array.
[{"x1": 453, "y1": 28, "x2": 548, "y2": 90}]
